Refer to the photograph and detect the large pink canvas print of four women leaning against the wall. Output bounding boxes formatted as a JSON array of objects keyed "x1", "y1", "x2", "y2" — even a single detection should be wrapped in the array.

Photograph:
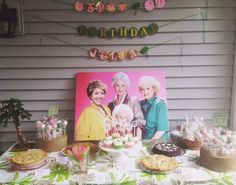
[{"x1": 74, "y1": 71, "x2": 170, "y2": 141}]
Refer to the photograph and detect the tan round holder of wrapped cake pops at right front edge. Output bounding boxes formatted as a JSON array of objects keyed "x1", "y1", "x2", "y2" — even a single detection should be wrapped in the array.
[{"x1": 199, "y1": 128, "x2": 236, "y2": 172}]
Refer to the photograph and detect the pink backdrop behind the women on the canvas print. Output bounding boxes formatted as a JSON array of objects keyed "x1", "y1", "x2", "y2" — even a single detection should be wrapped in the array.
[{"x1": 75, "y1": 71, "x2": 167, "y2": 129}]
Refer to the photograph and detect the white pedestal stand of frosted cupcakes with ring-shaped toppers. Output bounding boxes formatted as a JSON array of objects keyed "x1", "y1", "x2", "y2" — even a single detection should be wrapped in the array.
[{"x1": 99, "y1": 109, "x2": 142, "y2": 167}]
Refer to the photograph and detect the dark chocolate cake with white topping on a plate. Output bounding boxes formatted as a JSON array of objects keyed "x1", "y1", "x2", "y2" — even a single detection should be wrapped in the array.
[{"x1": 152, "y1": 142, "x2": 182, "y2": 157}]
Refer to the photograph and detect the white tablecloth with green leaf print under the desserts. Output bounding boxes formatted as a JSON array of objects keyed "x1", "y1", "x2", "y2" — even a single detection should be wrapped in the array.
[{"x1": 0, "y1": 143, "x2": 236, "y2": 185}]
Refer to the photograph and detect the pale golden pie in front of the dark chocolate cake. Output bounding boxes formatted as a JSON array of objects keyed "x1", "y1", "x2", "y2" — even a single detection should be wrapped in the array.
[{"x1": 140, "y1": 154, "x2": 178, "y2": 172}]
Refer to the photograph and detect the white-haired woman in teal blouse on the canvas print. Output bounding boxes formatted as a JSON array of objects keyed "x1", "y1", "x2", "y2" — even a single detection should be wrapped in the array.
[{"x1": 138, "y1": 76, "x2": 169, "y2": 139}]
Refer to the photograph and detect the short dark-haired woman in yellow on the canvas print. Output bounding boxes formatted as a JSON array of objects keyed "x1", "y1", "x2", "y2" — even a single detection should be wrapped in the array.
[{"x1": 75, "y1": 80, "x2": 111, "y2": 141}]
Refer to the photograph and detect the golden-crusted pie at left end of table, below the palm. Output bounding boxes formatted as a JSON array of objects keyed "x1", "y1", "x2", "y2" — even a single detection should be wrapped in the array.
[{"x1": 11, "y1": 149, "x2": 48, "y2": 170}]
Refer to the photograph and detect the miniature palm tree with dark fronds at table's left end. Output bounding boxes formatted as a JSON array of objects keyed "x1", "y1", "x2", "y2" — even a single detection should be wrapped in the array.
[{"x1": 0, "y1": 98, "x2": 32, "y2": 146}]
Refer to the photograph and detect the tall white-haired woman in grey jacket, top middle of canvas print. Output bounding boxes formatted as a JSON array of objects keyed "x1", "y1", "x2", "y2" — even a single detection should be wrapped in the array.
[{"x1": 108, "y1": 72, "x2": 145, "y2": 137}]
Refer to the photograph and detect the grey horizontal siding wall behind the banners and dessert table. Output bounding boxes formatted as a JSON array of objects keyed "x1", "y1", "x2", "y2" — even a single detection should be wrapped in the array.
[{"x1": 0, "y1": 0, "x2": 236, "y2": 152}]
